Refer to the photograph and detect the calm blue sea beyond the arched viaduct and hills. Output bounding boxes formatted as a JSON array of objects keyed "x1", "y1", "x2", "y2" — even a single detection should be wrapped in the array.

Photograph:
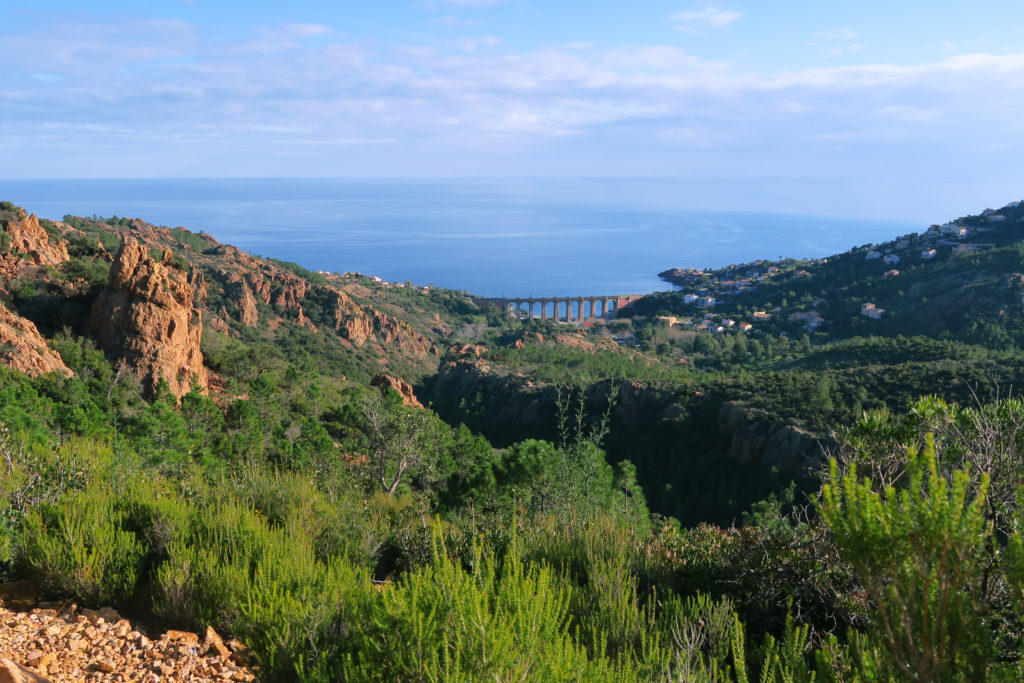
[{"x1": 0, "y1": 179, "x2": 925, "y2": 297}]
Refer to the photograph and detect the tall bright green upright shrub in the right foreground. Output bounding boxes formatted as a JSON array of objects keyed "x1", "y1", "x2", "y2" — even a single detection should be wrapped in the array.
[{"x1": 818, "y1": 437, "x2": 991, "y2": 681}]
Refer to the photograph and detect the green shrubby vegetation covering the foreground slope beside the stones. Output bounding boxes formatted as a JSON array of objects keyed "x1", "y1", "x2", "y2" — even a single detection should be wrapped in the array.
[{"x1": 8, "y1": 338, "x2": 1024, "y2": 681}]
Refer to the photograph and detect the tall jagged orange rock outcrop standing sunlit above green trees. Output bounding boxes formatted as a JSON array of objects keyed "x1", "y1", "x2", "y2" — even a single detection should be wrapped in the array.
[{"x1": 90, "y1": 238, "x2": 208, "y2": 397}]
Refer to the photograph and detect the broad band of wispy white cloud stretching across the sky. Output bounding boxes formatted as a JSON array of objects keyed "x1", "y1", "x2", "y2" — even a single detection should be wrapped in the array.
[{"x1": 6, "y1": 10, "x2": 1024, "y2": 183}]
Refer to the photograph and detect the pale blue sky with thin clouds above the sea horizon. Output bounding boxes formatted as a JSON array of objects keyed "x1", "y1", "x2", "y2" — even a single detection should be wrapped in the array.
[{"x1": 0, "y1": 0, "x2": 1024, "y2": 218}]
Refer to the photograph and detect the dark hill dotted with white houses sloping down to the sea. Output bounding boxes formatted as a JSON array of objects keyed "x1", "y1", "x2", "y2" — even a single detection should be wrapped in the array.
[{"x1": 651, "y1": 196, "x2": 1024, "y2": 349}]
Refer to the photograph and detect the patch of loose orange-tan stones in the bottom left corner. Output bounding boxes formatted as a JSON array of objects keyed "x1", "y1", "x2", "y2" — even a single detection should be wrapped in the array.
[{"x1": 0, "y1": 581, "x2": 256, "y2": 683}]
